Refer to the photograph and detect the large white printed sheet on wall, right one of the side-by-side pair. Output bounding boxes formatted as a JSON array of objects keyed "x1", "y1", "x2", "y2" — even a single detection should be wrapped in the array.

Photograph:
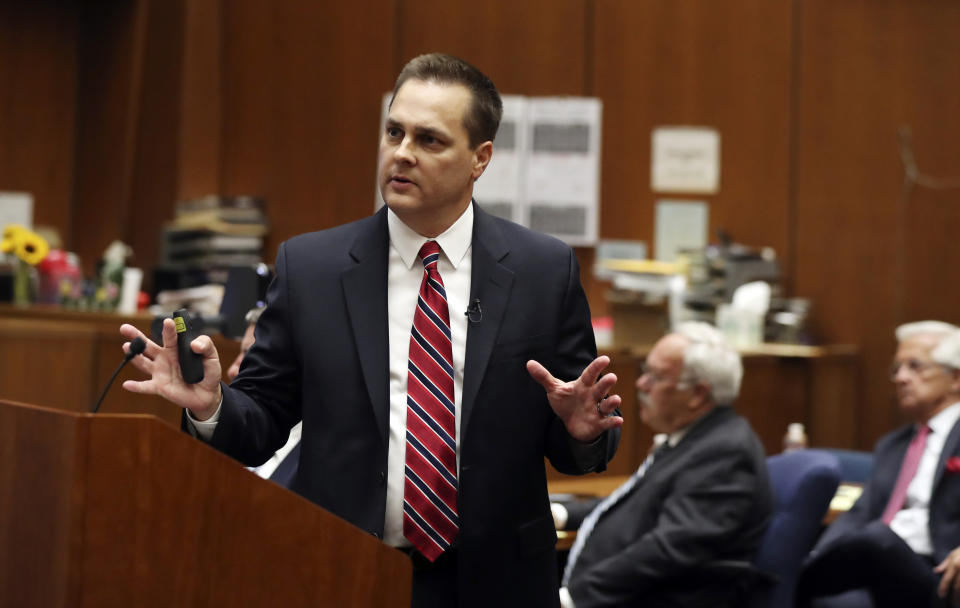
[{"x1": 524, "y1": 97, "x2": 603, "y2": 245}]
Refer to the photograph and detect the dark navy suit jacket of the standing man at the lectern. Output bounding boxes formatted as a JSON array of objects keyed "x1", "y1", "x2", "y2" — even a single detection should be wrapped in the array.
[{"x1": 211, "y1": 205, "x2": 619, "y2": 606}]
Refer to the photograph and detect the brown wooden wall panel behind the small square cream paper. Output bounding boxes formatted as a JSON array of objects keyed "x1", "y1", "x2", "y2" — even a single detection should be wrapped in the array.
[{"x1": 590, "y1": 0, "x2": 792, "y2": 279}]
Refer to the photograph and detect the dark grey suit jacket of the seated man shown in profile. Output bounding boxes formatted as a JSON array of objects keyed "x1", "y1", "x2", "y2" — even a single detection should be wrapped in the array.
[{"x1": 568, "y1": 407, "x2": 773, "y2": 608}]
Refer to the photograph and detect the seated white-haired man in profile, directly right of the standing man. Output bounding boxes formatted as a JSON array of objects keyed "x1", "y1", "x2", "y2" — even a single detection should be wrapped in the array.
[{"x1": 555, "y1": 323, "x2": 773, "y2": 608}]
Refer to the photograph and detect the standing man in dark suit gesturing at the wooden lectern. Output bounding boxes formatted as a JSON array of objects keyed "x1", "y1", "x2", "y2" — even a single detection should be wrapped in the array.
[{"x1": 121, "y1": 54, "x2": 623, "y2": 607}]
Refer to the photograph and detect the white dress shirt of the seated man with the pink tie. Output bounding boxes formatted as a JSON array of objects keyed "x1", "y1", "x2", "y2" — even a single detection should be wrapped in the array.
[{"x1": 890, "y1": 402, "x2": 960, "y2": 555}]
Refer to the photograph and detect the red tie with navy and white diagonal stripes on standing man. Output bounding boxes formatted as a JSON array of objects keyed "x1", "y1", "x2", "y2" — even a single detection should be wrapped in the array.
[{"x1": 403, "y1": 241, "x2": 460, "y2": 561}]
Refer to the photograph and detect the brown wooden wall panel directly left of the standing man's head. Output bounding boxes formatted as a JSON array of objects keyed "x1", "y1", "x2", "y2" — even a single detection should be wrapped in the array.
[{"x1": 220, "y1": 0, "x2": 396, "y2": 261}]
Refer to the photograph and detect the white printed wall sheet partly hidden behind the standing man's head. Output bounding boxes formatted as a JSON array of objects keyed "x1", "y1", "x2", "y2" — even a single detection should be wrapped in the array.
[{"x1": 473, "y1": 95, "x2": 528, "y2": 223}]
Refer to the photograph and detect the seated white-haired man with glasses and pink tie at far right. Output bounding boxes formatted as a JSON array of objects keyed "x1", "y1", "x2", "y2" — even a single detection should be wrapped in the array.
[{"x1": 798, "y1": 321, "x2": 960, "y2": 608}]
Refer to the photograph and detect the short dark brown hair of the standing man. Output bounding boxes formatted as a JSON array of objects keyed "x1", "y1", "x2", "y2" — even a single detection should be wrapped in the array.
[{"x1": 390, "y1": 53, "x2": 503, "y2": 148}]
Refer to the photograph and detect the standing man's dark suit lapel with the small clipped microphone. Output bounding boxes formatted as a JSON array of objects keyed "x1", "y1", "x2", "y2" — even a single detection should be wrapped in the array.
[{"x1": 460, "y1": 203, "x2": 513, "y2": 437}]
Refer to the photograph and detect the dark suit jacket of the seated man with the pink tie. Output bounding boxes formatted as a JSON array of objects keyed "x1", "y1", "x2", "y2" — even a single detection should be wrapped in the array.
[{"x1": 813, "y1": 422, "x2": 960, "y2": 563}]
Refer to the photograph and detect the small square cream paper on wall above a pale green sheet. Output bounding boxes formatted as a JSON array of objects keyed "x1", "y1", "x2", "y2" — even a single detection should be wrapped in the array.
[{"x1": 650, "y1": 127, "x2": 720, "y2": 194}]
